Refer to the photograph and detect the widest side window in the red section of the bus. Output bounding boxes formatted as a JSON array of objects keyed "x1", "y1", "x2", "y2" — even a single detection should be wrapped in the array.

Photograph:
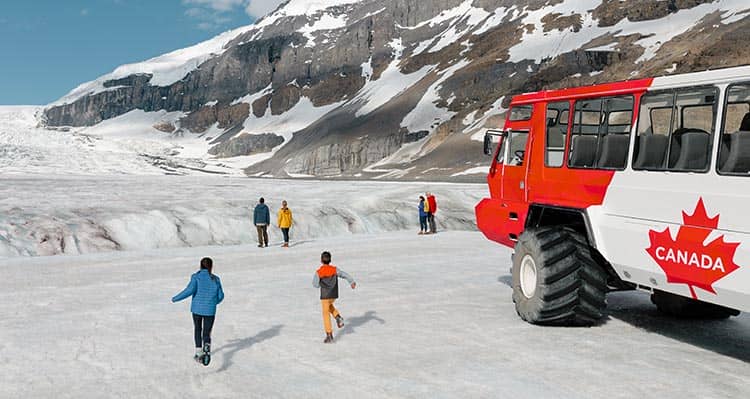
[{"x1": 568, "y1": 96, "x2": 633, "y2": 169}]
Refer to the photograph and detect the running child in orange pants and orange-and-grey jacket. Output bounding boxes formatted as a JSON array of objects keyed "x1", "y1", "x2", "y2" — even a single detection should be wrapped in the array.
[{"x1": 313, "y1": 251, "x2": 357, "y2": 344}]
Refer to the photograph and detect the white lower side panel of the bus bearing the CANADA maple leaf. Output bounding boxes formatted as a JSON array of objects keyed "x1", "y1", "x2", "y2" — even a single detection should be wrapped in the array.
[{"x1": 588, "y1": 171, "x2": 750, "y2": 311}]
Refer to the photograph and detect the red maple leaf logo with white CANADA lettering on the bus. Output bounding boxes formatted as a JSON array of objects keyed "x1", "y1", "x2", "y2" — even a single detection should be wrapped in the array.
[{"x1": 646, "y1": 198, "x2": 740, "y2": 299}]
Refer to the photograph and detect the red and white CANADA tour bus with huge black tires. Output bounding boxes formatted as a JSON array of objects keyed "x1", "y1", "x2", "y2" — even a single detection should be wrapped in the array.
[{"x1": 476, "y1": 66, "x2": 750, "y2": 325}]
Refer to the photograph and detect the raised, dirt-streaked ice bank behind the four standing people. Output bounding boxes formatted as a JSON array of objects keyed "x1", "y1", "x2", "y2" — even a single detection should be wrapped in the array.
[{"x1": 0, "y1": 174, "x2": 487, "y2": 258}]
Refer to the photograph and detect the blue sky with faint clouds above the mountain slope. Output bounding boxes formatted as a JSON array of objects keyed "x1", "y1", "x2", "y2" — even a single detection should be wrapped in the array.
[{"x1": 0, "y1": 0, "x2": 283, "y2": 105}]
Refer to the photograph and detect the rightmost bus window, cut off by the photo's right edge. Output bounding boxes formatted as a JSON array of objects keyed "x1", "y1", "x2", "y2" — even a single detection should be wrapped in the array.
[{"x1": 717, "y1": 84, "x2": 750, "y2": 176}]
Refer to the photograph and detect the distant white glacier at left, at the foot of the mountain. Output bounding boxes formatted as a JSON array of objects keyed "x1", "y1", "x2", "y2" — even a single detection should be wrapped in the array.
[{"x1": 0, "y1": 104, "x2": 341, "y2": 176}]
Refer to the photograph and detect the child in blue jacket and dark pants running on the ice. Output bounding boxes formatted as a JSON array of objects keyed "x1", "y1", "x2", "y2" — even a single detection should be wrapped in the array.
[{"x1": 172, "y1": 258, "x2": 224, "y2": 361}]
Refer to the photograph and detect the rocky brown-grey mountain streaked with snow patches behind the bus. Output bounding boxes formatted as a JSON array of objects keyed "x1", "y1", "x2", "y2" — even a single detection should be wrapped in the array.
[{"x1": 43, "y1": 0, "x2": 750, "y2": 180}]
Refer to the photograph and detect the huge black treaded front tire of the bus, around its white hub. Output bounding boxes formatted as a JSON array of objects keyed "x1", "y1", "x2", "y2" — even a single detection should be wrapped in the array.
[{"x1": 512, "y1": 227, "x2": 607, "y2": 326}]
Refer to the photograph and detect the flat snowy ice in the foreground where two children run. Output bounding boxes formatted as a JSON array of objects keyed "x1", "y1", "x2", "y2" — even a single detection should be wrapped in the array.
[{"x1": 0, "y1": 232, "x2": 750, "y2": 399}]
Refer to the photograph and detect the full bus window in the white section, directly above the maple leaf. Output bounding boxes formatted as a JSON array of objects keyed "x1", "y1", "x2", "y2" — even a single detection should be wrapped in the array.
[{"x1": 633, "y1": 87, "x2": 717, "y2": 172}]
